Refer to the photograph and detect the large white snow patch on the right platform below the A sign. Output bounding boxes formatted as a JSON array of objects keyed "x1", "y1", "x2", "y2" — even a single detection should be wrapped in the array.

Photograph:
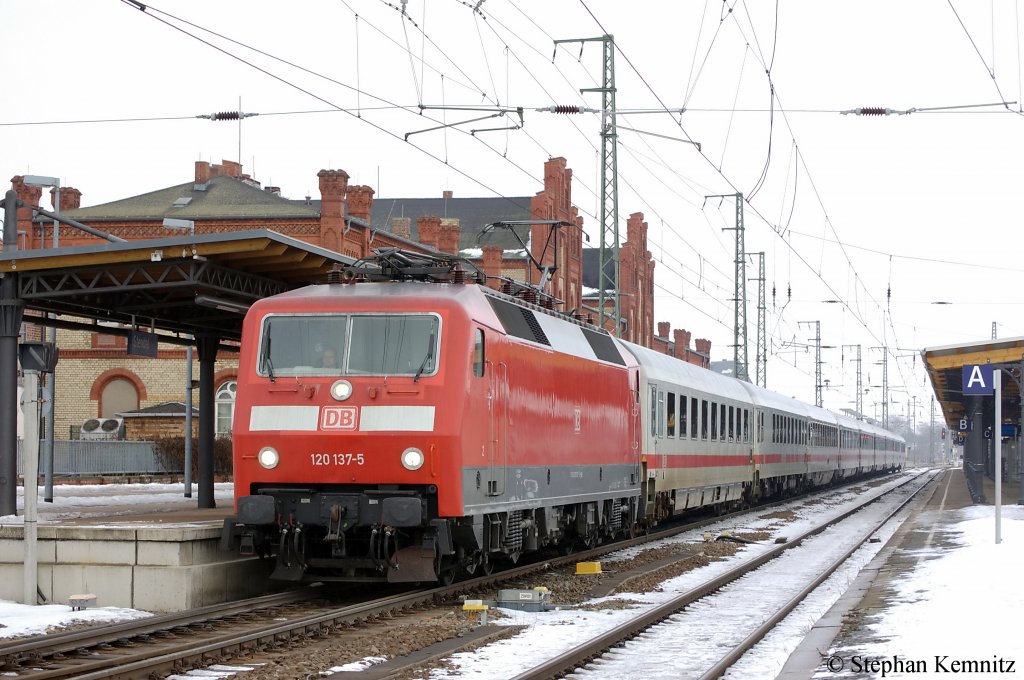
[{"x1": 815, "y1": 505, "x2": 1024, "y2": 678}]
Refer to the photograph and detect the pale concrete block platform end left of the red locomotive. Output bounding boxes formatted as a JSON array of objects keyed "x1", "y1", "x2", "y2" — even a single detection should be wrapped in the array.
[{"x1": 0, "y1": 484, "x2": 271, "y2": 612}]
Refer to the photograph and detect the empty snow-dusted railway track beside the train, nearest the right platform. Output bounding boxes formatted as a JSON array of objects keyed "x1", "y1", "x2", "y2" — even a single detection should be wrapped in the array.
[{"x1": 503, "y1": 473, "x2": 933, "y2": 680}]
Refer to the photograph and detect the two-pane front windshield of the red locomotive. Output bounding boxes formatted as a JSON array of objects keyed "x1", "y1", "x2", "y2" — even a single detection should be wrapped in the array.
[{"x1": 256, "y1": 314, "x2": 440, "y2": 379}]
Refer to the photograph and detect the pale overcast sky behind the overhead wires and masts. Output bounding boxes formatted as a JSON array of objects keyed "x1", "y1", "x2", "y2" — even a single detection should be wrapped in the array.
[{"x1": 0, "y1": 0, "x2": 1024, "y2": 432}]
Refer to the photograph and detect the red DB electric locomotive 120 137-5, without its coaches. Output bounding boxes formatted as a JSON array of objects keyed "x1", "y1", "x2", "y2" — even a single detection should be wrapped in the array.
[{"x1": 225, "y1": 251, "x2": 642, "y2": 582}]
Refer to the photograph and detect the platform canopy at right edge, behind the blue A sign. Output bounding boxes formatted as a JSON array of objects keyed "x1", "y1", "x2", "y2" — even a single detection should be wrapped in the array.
[{"x1": 921, "y1": 338, "x2": 1024, "y2": 429}]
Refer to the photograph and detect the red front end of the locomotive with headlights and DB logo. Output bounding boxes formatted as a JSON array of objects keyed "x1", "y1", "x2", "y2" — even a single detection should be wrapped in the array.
[{"x1": 225, "y1": 284, "x2": 473, "y2": 582}]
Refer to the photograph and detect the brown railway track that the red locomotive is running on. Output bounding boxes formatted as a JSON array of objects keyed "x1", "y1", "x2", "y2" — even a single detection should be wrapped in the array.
[{"x1": 0, "y1": 471, "x2": 913, "y2": 680}]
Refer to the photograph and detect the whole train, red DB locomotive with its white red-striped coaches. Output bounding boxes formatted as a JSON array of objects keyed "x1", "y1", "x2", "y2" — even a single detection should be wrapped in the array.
[{"x1": 224, "y1": 250, "x2": 903, "y2": 582}]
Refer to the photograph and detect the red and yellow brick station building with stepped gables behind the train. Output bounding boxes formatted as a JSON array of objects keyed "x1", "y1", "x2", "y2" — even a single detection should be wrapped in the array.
[{"x1": 11, "y1": 158, "x2": 711, "y2": 438}]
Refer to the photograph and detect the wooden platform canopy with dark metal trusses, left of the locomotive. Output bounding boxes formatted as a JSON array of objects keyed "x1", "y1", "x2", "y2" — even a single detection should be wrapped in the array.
[{"x1": 0, "y1": 229, "x2": 353, "y2": 343}]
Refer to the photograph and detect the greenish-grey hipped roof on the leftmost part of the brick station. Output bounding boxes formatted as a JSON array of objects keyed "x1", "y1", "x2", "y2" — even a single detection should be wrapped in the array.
[{"x1": 60, "y1": 175, "x2": 319, "y2": 222}]
